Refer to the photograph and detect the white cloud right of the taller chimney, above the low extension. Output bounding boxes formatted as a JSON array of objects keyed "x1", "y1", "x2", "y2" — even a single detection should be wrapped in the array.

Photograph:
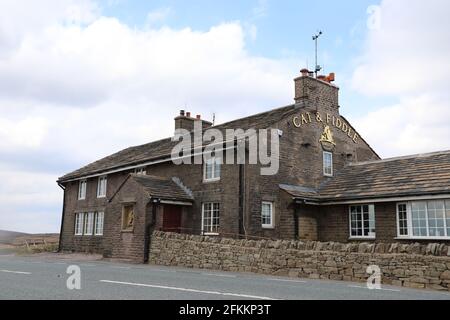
[{"x1": 352, "y1": 0, "x2": 450, "y2": 156}]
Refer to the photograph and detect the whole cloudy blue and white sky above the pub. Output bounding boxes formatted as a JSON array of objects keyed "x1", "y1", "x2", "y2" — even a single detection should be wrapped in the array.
[{"x1": 0, "y1": 0, "x2": 450, "y2": 233}]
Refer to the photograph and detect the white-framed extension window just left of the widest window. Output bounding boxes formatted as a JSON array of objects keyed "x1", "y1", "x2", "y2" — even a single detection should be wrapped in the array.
[{"x1": 350, "y1": 204, "x2": 376, "y2": 239}]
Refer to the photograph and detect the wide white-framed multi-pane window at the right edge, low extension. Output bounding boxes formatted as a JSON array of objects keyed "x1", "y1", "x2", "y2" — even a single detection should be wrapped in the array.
[{"x1": 397, "y1": 200, "x2": 450, "y2": 239}]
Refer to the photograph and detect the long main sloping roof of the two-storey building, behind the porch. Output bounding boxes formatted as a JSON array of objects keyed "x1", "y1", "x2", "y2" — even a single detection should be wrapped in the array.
[{"x1": 58, "y1": 104, "x2": 304, "y2": 182}]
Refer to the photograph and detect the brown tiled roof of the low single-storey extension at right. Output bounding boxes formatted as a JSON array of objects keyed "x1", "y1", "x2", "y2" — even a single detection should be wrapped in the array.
[{"x1": 280, "y1": 150, "x2": 450, "y2": 202}]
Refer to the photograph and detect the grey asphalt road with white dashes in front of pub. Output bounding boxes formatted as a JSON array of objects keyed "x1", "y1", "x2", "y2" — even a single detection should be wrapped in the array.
[{"x1": 0, "y1": 251, "x2": 450, "y2": 300}]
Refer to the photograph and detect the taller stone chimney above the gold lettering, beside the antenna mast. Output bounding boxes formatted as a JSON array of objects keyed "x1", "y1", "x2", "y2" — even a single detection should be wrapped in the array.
[{"x1": 294, "y1": 69, "x2": 339, "y2": 112}]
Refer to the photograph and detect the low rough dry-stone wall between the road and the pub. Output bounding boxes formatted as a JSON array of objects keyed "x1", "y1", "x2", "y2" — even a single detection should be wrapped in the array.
[{"x1": 150, "y1": 232, "x2": 450, "y2": 291}]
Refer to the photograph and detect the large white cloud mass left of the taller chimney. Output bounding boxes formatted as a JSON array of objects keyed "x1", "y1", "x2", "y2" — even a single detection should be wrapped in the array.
[{"x1": 0, "y1": 0, "x2": 302, "y2": 231}]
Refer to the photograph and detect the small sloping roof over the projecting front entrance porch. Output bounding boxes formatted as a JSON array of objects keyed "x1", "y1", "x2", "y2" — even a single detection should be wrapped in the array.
[{"x1": 130, "y1": 174, "x2": 194, "y2": 201}]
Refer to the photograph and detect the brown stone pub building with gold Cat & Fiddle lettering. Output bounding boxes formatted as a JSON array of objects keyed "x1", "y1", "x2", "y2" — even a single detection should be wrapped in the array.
[{"x1": 58, "y1": 69, "x2": 450, "y2": 262}]
